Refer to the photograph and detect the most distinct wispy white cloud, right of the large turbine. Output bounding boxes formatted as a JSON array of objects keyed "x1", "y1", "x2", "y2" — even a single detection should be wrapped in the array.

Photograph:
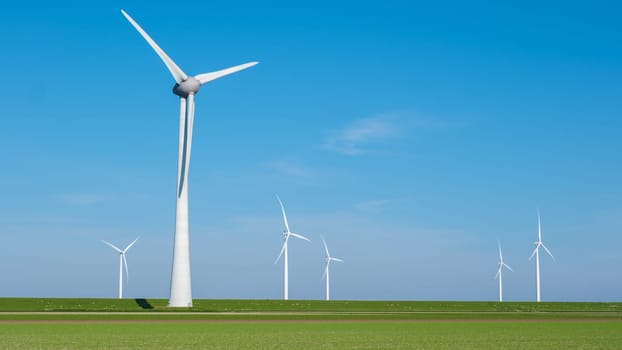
[{"x1": 323, "y1": 115, "x2": 399, "y2": 156}]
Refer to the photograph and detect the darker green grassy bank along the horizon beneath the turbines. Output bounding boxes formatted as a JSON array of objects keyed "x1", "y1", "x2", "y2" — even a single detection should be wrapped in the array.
[{"x1": 0, "y1": 298, "x2": 622, "y2": 315}]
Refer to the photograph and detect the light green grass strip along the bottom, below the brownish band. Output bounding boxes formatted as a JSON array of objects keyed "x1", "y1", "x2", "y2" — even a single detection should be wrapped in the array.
[{"x1": 0, "y1": 321, "x2": 622, "y2": 350}]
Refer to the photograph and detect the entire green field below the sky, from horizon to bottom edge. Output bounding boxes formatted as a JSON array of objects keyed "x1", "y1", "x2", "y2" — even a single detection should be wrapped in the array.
[{"x1": 0, "y1": 298, "x2": 622, "y2": 350}]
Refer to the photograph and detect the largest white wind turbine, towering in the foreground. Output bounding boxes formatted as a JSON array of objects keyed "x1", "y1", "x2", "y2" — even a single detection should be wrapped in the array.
[{"x1": 121, "y1": 10, "x2": 258, "y2": 307}]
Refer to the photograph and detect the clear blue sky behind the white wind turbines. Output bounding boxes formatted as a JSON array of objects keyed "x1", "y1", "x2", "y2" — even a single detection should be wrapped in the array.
[{"x1": 0, "y1": 0, "x2": 622, "y2": 301}]
